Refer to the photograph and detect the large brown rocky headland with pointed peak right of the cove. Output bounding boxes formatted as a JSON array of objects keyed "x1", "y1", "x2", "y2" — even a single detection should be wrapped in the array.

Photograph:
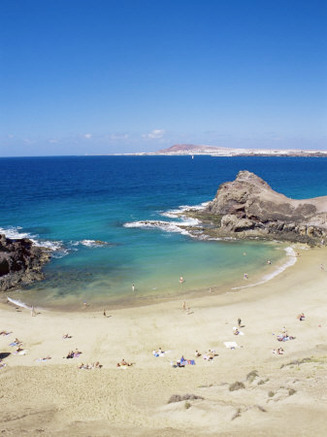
[{"x1": 202, "y1": 171, "x2": 327, "y2": 245}]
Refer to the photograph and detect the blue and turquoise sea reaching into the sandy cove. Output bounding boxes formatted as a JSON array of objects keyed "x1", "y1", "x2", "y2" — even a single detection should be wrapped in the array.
[{"x1": 0, "y1": 156, "x2": 327, "y2": 309}]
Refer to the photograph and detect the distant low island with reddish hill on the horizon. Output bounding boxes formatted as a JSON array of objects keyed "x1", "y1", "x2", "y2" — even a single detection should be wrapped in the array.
[{"x1": 131, "y1": 144, "x2": 327, "y2": 157}]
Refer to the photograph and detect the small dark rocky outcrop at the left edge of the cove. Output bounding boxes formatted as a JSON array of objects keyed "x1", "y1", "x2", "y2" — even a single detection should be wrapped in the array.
[{"x1": 0, "y1": 235, "x2": 51, "y2": 291}]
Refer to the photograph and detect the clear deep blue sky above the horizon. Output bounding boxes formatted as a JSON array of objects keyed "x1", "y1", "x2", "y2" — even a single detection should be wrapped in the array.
[{"x1": 0, "y1": 0, "x2": 327, "y2": 156}]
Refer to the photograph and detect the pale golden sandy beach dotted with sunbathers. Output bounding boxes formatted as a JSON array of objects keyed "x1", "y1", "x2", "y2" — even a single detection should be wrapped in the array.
[{"x1": 0, "y1": 248, "x2": 327, "y2": 437}]
